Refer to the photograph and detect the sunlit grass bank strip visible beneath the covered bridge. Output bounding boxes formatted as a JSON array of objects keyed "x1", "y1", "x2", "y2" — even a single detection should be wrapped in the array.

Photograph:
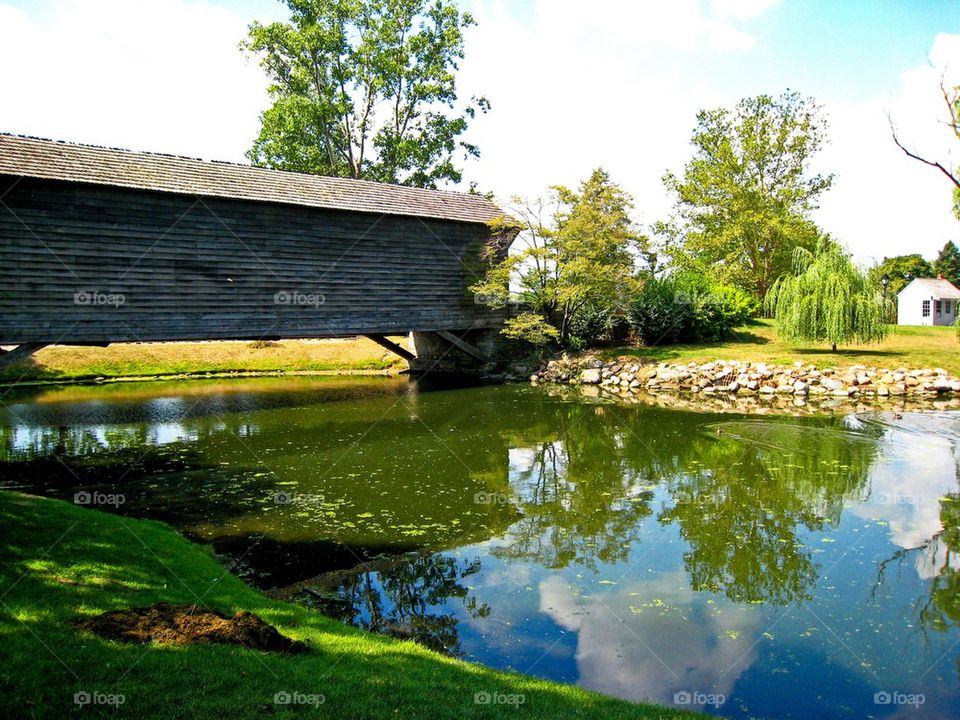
[{"x1": 0, "y1": 338, "x2": 407, "y2": 383}]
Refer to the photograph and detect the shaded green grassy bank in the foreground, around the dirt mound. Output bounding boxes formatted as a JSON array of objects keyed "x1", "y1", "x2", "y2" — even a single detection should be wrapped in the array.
[{"x1": 0, "y1": 492, "x2": 695, "y2": 720}]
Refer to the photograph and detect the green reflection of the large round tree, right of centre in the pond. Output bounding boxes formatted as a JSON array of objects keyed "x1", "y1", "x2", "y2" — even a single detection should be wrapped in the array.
[{"x1": 659, "y1": 423, "x2": 876, "y2": 604}]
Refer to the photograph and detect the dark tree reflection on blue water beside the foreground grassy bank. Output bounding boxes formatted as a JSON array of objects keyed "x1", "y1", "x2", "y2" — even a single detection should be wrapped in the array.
[{"x1": 301, "y1": 555, "x2": 490, "y2": 655}]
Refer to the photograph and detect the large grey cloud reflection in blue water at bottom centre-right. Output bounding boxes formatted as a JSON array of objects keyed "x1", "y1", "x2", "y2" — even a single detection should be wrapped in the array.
[{"x1": 540, "y1": 572, "x2": 760, "y2": 709}]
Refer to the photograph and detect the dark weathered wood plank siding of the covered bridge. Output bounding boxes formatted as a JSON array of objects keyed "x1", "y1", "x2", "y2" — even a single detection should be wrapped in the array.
[{"x1": 0, "y1": 176, "x2": 501, "y2": 344}]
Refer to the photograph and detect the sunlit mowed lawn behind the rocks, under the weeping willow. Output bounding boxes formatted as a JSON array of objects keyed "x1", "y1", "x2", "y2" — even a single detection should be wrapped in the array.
[{"x1": 601, "y1": 320, "x2": 960, "y2": 375}]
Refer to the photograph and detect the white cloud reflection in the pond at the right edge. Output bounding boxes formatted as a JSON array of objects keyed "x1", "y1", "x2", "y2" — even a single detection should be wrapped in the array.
[{"x1": 851, "y1": 431, "x2": 957, "y2": 548}]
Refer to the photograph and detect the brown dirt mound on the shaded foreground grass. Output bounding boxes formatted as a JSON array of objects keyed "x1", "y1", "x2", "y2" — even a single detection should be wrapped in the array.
[{"x1": 73, "y1": 603, "x2": 309, "y2": 654}]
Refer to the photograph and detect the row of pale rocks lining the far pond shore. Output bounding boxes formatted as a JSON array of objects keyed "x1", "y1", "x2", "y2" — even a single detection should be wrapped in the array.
[{"x1": 530, "y1": 356, "x2": 960, "y2": 398}]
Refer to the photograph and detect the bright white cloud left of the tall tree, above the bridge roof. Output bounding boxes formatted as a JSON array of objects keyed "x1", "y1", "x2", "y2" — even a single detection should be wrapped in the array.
[{"x1": 0, "y1": 0, "x2": 267, "y2": 160}]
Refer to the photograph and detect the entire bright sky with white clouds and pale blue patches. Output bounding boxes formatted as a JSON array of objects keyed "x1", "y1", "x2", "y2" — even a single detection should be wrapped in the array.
[{"x1": 0, "y1": 0, "x2": 960, "y2": 264}]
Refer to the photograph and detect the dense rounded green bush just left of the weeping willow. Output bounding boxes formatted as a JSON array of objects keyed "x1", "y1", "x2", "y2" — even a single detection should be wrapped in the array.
[{"x1": 628, "y1": 273, "x2": 760, "y2": 346}]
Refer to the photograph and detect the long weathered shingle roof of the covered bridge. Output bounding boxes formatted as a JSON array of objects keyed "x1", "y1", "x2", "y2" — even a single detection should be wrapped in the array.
[{"x1": 0, "y1": 133, "x2": 503, "y2": 223}]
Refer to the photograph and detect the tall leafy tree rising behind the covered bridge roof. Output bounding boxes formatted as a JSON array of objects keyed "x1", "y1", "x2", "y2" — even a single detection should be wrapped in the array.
[{"x1": 241, "y1": 0, "x2": 489, "y2": 188}]
